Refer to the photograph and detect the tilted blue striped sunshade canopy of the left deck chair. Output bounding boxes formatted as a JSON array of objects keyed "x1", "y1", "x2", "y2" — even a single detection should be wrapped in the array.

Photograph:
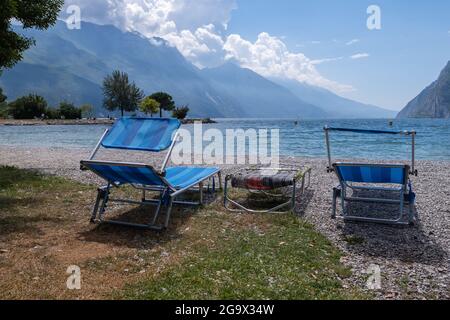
[{"x1": 102, "y1": 118, "x2": 181, "y2": 152}]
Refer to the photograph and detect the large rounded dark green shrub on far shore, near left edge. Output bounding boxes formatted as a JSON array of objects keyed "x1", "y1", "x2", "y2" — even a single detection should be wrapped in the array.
[{"x1": 8, "y1": 94, "x2": 47, "y2": 119}]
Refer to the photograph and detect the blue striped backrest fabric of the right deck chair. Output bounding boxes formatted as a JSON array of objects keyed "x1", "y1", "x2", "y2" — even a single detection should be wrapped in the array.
[{"x1": 335, "y1": 164, "x2": 409, "y2": 184}]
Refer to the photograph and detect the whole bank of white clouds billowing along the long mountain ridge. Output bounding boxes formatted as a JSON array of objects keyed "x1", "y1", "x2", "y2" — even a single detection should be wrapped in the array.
[{"x1": 61, "y1": 0, "x2": 353, "y2": 93}]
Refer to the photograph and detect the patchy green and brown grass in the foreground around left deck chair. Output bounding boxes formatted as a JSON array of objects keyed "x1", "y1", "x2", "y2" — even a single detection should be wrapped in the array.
[{"x1": 0, "y1": 167, "x2": 366, "y2": 299}]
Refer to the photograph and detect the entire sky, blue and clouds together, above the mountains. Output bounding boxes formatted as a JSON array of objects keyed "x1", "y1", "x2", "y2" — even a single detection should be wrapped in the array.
[{"x1": 65, "y1": 0, "x2": 450, "y2": 110}]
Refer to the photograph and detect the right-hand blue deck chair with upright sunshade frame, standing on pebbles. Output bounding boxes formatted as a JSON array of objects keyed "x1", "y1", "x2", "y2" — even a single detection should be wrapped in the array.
[{"x1": 324, "y1": 127, "x2": 418, "y2": 225}]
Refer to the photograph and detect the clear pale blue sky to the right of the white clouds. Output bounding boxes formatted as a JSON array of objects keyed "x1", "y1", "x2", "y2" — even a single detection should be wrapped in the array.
[{"x1": 227, "y1": 0, "x2": 450, "y2": 110}]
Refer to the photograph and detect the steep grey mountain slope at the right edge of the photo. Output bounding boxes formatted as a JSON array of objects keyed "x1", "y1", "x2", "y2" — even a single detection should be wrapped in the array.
[{"x1": 397, "y1": 61, "x2": 450, "y2": 119}]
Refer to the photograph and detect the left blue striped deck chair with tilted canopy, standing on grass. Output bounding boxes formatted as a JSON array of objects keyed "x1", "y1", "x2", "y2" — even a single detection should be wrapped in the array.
[{"x1": 81, "y1": 118, "x2": 221, "y2": 231}]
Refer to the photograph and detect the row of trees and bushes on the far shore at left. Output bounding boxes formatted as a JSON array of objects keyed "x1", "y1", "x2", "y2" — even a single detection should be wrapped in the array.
[{"x1": 0, "y1": 79, "x2": 214, "y2": 126}]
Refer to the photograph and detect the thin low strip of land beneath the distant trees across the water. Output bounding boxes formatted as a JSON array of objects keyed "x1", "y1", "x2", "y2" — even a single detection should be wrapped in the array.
[{"x1": 0, "y1": 118, "x2": 216, "y2": 126}]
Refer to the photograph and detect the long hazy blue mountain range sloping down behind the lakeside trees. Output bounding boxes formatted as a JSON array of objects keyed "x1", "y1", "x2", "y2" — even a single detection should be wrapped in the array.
[{"x1": 0, "y1": 21, "x2": 394, "y2": 119}]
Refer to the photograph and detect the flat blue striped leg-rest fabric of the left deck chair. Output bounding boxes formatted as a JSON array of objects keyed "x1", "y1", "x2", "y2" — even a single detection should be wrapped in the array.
[{"x1": 165, "y1": 167, "x2": 220, "y2": 189}]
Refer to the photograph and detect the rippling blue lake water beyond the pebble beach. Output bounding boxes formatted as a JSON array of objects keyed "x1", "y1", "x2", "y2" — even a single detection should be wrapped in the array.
[{"x1": 0, "y1": 119, "x2": 450, "y2": 160}]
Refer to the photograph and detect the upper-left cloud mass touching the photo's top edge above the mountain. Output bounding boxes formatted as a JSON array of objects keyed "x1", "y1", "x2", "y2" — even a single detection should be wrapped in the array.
[{"x1": 65, "y1": 0, "x2": 236, "y2": 67}]
